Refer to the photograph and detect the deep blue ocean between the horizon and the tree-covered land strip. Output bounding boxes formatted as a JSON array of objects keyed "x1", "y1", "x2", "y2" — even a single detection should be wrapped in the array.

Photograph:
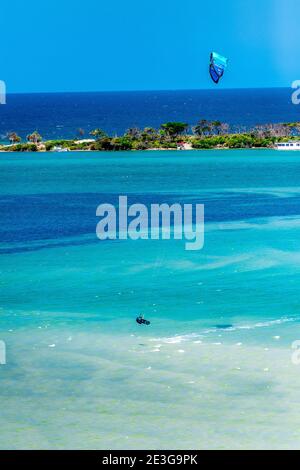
[{"x1": 0, "y1": 88, "x2": 300, "y2": 140}]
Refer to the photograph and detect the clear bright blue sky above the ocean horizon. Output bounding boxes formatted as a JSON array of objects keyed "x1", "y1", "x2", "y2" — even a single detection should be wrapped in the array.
[{"x1": 0, "y1": 0, "x2": 300, "y2": 93}]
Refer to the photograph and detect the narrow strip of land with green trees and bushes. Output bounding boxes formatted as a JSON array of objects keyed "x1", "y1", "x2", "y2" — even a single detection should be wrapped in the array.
[{"x1": 0, "y1": 119, "x2": 300, "y2": 152}]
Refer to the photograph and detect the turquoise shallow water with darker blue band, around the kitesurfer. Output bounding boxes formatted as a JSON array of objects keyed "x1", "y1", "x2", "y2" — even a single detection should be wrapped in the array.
[{"x1": 0, "y1": 150, "x2": 300, "y2": 449}]
